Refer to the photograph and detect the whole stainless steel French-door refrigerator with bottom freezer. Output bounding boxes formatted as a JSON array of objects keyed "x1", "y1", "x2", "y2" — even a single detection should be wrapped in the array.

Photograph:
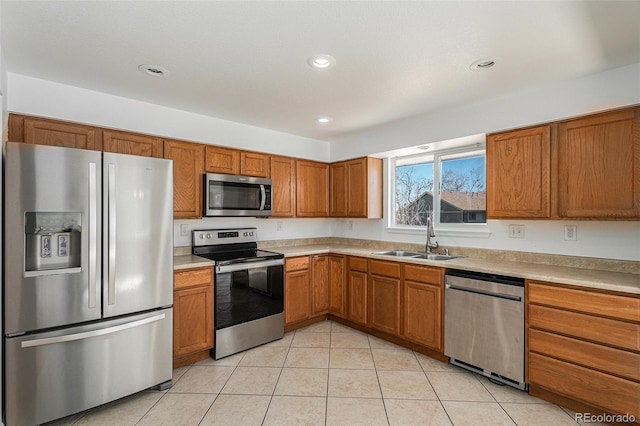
[{"x1": 3, "y1": 142, "x2": 173, "y2": 426}]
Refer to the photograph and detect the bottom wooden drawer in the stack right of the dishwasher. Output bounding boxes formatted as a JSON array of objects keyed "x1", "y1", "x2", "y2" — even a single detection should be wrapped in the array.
[{"x1": 529, "y1": 354, "x2": 640, "y2": 418}]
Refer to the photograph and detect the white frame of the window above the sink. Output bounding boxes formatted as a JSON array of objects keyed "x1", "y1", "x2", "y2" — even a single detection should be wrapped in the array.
[{"x1": 387, "y1": 143, "x2": 491, "y2": 238}]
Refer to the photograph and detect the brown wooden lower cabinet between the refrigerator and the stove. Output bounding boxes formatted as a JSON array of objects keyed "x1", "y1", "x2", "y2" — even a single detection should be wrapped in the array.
[{"x1": 173, "y1": 267, "x2": 214, "y2": 368}]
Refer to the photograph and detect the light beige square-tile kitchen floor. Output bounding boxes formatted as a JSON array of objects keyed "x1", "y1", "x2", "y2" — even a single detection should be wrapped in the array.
[{"x1": 47, "y1": 321, "x2": 604, "y2": 426}]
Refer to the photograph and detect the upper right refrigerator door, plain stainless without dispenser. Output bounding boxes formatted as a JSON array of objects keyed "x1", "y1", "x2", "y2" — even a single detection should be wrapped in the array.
[{"x1": 102, "y1": 153, "x2": 173, "y2": 317}]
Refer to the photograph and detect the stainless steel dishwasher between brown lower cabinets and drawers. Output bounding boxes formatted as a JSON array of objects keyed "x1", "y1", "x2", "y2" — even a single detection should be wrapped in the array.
[{"x1": 444, "y1": 270, "x2": 527, "y2": 390}]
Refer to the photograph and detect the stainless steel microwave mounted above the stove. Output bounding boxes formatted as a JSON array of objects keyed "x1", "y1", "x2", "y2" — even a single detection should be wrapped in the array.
[{"x1": 204, "y1": 173, "x2": 272, "y2": 217}]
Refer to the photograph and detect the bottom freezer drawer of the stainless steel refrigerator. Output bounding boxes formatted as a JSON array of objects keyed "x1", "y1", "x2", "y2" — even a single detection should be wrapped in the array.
[{"x1": 5, "y1": 308, "x2": 173, "y2": 425}]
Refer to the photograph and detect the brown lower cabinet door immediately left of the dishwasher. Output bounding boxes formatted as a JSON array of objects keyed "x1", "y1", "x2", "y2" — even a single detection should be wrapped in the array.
[{"x1": 403, "y1": 280, "x2": 443, "y2": 351}]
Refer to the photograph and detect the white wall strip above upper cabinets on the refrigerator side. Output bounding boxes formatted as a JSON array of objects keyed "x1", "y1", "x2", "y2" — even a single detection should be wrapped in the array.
[{"x1": 8, "y1": 73, "x2": 329, "y2": 161}]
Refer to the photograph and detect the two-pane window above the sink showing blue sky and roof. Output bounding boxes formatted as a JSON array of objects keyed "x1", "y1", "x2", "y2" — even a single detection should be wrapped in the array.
[{"x1": 391, "y1": 146, "x2": 487, "y2": 228}]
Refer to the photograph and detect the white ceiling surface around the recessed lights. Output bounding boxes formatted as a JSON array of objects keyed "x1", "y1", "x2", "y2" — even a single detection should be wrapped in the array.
[{"x1": 0, "y1": 0, "x2": 640, "y2": 141}]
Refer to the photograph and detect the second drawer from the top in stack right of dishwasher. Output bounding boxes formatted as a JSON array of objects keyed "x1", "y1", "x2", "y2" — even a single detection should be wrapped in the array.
[{"x1": 528, "y1": 305, "x2": 640, "y2": 351}]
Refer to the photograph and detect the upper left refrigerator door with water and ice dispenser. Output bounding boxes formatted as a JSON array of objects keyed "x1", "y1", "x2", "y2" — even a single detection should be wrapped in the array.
[{"x1": 4, "y1": 142, "x2": 101, "y2": 334}]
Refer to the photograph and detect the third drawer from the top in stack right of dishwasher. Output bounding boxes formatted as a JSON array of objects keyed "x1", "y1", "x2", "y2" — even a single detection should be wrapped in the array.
[{"x1": 527, "y1": 329, "x2": 640, "y2": 382}]
